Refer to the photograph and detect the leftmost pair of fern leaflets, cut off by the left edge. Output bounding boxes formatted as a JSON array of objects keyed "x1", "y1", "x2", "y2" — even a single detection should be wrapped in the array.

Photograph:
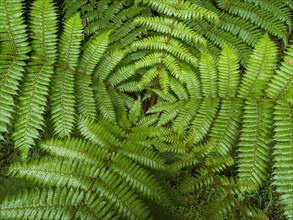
[{"x1": 0, "y1": 1, "x2": 30, "y2": 140}]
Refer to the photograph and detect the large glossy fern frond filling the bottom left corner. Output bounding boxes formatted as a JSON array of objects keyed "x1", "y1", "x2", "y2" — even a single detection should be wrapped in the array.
[{"x1": 0, "y1": 139, "x2": 168, "y2": 219}]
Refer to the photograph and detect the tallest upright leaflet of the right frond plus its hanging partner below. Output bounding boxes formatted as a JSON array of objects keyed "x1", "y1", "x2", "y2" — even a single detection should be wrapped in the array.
[{"x1": 238, "y1": 35, "x2": 276, "y2": 188}]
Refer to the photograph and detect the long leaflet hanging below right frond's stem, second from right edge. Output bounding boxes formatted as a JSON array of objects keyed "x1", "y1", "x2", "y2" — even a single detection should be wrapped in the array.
[{"x1": 238, "y1": 100, "x2": 273, "y2": 187}]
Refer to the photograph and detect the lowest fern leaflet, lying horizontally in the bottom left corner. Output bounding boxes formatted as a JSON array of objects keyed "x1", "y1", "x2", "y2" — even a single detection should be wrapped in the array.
[{"x1": 0, "y1": 189, "x2": 86, "y2": 219}]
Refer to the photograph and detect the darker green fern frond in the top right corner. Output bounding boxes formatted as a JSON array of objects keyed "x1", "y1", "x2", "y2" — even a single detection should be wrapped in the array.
[{"x1": 189, "y1": 0, "x2": 292, "y2": 65}]
